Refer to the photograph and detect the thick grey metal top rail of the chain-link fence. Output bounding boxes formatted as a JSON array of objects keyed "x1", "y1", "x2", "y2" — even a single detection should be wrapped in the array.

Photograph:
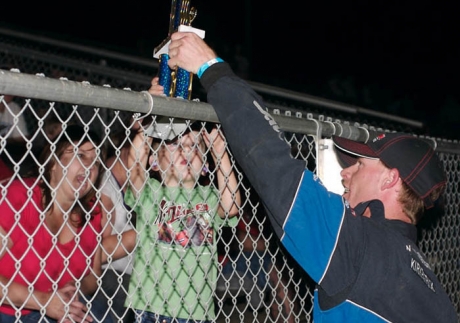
[{"x1": 0, "y1": 70, "x2": 369, "y2": 141}]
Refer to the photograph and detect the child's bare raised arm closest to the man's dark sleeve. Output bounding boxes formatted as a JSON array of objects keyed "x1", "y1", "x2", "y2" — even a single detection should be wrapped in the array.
[{"x1": 203, "y1": 129, "x2": 241, "y2": 218}]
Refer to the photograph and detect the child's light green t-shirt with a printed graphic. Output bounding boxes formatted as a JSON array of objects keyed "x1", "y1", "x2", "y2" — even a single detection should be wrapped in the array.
[{"x1": 125, "y1": 178, "x2": 238, "y2": 320}]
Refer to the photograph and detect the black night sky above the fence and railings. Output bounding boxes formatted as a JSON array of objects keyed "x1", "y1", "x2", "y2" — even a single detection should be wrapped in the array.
[{"x1": 0, "y1": 0, "x2": 460, "y2": 139}]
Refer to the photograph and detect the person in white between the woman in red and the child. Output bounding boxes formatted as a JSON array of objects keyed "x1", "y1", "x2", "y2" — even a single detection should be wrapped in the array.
[{"x1": 97, "y1": 125, "x2": 136, "y2": 323}]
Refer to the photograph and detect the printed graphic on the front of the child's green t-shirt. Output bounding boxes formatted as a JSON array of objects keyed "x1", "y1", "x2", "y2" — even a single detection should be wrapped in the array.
[{"x1": 157, "y1": 200, "x2": 213, "y2": 247}]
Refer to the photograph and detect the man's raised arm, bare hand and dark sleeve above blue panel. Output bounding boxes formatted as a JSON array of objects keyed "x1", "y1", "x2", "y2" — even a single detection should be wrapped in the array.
[{"x1": 168, "y1": 32, "x2": 313, "y2": 235}]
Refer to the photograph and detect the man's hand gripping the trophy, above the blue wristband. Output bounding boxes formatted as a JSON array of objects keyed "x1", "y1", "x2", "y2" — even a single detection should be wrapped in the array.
[{"x1": 168, "y1": 32, "x2": 217, "y2": 74}]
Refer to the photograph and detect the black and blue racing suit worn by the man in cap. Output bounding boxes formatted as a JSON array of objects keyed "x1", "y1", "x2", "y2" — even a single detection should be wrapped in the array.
[{"x1": 201, "y1": 62, "x2": 458, "y2": 323}]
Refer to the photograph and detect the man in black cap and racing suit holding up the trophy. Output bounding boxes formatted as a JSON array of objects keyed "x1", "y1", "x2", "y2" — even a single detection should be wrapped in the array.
[{"x1": 164, "y1": 33, "x2": 458, "y2": 323}]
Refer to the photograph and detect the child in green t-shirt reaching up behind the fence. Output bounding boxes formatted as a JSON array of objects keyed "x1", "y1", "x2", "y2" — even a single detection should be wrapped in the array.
[{"x1": 125, "y1": 102, "x2": 240, "y2": 323}]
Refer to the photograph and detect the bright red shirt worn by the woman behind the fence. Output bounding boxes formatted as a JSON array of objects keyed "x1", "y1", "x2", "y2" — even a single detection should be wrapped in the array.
[{"x1": 0, "y1": 178, "x2": 102, "y2": 315}]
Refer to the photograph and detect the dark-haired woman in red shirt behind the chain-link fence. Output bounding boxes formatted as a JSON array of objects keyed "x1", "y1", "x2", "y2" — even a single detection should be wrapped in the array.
[{"x1": 0, "y1": 126, "x2": 111, "y2": 323}]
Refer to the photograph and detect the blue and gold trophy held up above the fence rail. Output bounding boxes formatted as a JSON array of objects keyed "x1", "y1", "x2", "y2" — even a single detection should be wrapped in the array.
[{"x1": 153, "y1": 0, "x2": 204, "y2": 100}]
